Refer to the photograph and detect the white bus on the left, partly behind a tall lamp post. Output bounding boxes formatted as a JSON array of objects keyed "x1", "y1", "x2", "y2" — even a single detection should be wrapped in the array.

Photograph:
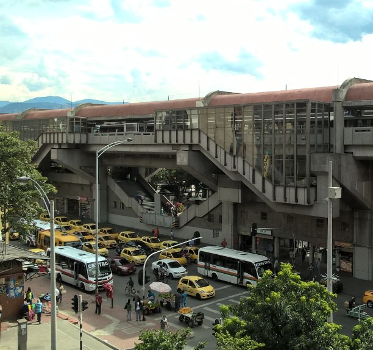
[{"x1": 55, "y1": 246, "x2": 113, "y2": 291}]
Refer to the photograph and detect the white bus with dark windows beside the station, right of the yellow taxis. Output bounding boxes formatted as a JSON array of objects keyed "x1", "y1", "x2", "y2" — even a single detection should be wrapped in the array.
[{"x1": 198, "y1": 246, "x2": 272, "y2": 286}]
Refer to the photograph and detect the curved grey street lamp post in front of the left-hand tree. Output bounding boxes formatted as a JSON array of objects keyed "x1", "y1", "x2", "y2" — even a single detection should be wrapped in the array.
[{"x1": 17, "y1": 176, "x2": 57, "y2": 350}]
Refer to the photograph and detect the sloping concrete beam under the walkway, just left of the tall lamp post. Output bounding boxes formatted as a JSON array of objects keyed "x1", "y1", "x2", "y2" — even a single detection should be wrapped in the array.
[{"x1": 51, "y1": 148, "x2": 95, "y2": 183}]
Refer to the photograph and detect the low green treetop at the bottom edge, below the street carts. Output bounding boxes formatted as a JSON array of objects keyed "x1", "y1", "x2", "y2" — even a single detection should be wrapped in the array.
[{"x1": 135, "y1": 328, "x2": 205, "y2": 350}]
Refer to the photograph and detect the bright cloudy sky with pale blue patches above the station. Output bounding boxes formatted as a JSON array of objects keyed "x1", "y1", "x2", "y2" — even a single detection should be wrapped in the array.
[{"x1": 0, "y1": 0, "x2": 373, "y2": 102}]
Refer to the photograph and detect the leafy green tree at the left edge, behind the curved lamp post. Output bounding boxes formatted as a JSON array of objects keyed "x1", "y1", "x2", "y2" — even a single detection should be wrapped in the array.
[{"x1": 0, "y1": 126, "x2": 55, "y2": 238}]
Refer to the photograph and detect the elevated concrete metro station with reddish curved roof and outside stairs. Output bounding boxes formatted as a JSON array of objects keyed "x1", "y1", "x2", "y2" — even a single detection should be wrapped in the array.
[{"x1": 0, "y1": 78, "x2": 373, "y2": 280}]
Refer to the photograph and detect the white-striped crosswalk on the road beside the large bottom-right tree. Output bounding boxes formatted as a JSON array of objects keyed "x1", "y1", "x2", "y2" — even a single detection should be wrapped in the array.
[{"x1": 156, "y1": 291, "x2": 249, "y2": 329}]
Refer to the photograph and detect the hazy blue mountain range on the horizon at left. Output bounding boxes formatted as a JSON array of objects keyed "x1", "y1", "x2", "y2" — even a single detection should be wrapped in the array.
[{"x1": 0, "y1": 96, "x2": 128, "y2": 114}]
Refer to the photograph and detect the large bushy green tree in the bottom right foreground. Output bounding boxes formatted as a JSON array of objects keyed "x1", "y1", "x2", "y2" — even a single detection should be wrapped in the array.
[{"x1": 219, "y1": 264, "x2": 350, "y2": 350}]
